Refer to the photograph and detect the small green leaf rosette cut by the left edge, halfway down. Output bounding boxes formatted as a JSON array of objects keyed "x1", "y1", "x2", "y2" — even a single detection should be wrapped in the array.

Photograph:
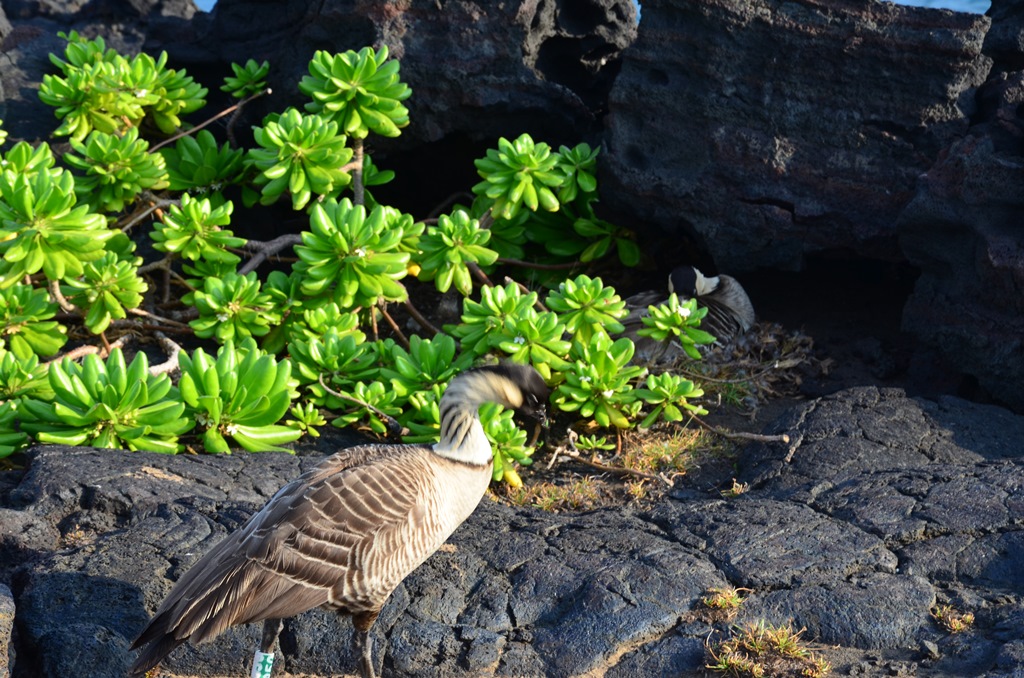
[{"x1": 0, "y1": 285, "x2": 68, "y2": 361}]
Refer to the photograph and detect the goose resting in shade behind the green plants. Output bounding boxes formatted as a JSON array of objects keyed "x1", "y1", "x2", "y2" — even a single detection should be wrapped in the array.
[{"x1": 623, "y1": 266, "x2": 754, "y2": 363}]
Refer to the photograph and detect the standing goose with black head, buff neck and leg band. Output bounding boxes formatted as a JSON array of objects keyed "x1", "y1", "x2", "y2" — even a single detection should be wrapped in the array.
[{"x1": 131, "y1": 364, "x2": 548, "y2": 678}]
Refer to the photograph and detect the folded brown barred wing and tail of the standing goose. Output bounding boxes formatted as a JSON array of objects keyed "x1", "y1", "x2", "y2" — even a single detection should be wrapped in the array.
[{"x1": 133, "y1": 446, "x2": 432, "y2": 664}]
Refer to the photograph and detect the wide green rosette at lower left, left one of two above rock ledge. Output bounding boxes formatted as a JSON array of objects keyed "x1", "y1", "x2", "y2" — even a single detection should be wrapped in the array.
[{"x1": 20, "y1": 348, "x2": 191, "y2": 454}]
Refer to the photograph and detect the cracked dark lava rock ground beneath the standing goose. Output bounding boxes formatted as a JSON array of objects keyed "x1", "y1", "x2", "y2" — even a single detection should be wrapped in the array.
[{"x1": 0, "y1": 387, "x2": 1024, "y2": 677}]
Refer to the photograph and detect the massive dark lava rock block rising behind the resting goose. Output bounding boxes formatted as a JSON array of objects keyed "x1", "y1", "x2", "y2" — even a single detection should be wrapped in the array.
[{"x1": 601, "y1": 0, "x2": 990, "y2": 272}]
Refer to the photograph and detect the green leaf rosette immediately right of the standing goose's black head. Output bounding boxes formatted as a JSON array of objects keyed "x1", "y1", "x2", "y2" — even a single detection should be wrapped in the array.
[{"x1": 553, "y1": 333, "x2": 644, "y2": 428}]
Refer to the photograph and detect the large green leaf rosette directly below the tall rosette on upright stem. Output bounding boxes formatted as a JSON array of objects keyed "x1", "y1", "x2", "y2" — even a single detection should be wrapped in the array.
[{"x1": 295, "y1": 198, "x2": 413, "y2": 308}]
